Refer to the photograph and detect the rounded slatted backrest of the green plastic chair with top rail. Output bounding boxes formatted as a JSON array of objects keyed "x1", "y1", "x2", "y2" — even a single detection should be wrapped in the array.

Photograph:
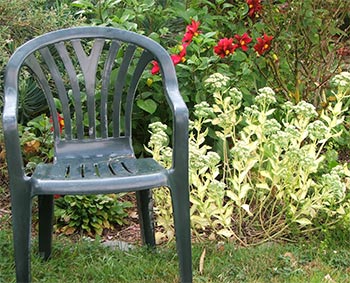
[{"x1": 5, "y1": 27, "x2": 177, "y2": 160}]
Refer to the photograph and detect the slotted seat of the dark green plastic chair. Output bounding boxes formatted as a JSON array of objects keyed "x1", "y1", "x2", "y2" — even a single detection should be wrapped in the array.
[{"x1": 31, "y1": 157, "x2": 168, "y2": 195}]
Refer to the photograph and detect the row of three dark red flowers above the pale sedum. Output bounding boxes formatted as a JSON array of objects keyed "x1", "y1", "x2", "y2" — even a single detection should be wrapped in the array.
[{"x1": 214, "y1": 33, "x2": 273, "y2": 58}]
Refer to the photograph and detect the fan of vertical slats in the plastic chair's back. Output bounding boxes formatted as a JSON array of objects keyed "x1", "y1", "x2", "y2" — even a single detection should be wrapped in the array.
[{"x1": 21, "y1": 35, "x2": 154, "y2": 144}]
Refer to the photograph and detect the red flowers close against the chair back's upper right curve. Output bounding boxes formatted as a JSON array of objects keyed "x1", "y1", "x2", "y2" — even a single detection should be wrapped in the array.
[{"x1": 151, "y1": 20, "x2": 200, "y2": 75}]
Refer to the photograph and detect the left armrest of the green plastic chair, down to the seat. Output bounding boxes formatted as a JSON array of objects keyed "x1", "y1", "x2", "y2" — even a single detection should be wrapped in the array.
[{"x1": 2, "y1": 86, "x2": 25, "y2": 179}]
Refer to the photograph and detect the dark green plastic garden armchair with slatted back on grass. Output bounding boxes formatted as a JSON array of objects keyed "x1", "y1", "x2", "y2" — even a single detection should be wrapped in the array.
[{"x1": 3, "y1": 27, "x2": 192, "y2": 282}]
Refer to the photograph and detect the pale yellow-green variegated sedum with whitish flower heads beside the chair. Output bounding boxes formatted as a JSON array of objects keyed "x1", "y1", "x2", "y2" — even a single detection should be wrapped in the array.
[{"x1": 148, "y1": 72, "x2": 350, "y2": 244}]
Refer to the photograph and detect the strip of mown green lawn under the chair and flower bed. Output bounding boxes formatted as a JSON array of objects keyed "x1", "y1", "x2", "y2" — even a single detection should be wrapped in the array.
[{"x1": 0, "y1": 229, "x2": 350, "y2": 283}]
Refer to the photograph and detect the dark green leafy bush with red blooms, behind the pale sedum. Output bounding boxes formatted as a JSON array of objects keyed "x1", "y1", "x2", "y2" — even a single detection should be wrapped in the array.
[{"x1": 72, "y1": 0, "x2": 350, "y2": 151}]
